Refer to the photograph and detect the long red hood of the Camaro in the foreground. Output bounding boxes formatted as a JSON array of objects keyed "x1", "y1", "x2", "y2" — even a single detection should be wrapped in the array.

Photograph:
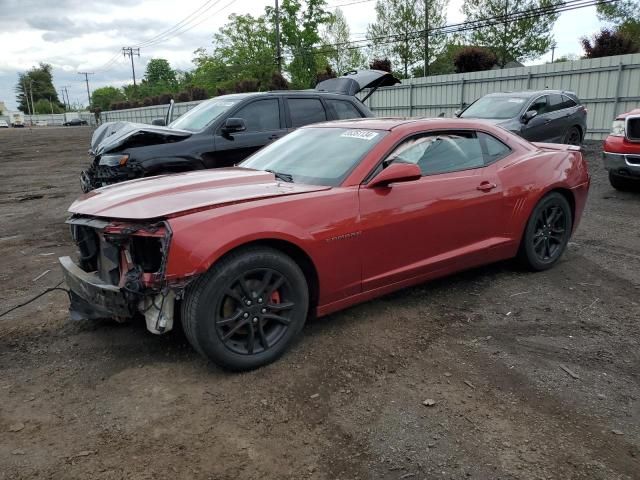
[{"x1": 69, "y1": 167, "x2": 331, "y2": 220}]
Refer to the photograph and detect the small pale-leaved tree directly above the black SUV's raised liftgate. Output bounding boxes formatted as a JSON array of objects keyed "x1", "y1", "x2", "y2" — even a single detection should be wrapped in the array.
[{"x1": 321, "y1": 8, "x2": 366, "y2": 75}]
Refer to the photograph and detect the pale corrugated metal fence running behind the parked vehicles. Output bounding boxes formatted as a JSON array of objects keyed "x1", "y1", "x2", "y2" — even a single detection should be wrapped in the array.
[{"x1": 94, "y1": 54, "x2": 640, "y2": 140}]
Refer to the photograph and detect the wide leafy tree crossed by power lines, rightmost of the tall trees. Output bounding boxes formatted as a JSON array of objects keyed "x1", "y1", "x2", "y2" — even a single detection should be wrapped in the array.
[{"x1": 462, "y1": 0, "x2": 561, "y2": 67}]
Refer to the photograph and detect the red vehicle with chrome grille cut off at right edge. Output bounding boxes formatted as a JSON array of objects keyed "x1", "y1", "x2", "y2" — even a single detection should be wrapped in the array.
[{"x1": 602, "y1": 108, "x2": 640, "y2": 190}]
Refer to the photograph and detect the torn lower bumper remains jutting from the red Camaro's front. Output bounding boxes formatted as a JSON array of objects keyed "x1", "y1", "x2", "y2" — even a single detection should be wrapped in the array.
[{"x1": 58, "y1": 257, "x2": 134, "y2": 320}]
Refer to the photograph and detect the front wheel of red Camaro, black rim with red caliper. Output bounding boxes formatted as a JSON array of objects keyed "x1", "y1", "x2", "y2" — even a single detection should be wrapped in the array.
[{"x1": 182, "y1": 246, "x2": 309, "y2": 371}]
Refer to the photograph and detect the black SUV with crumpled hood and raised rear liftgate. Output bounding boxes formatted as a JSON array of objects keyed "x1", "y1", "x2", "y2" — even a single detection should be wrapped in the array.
[{"x1": 81, "y1": 70, "x2": 399, "y2": 192}]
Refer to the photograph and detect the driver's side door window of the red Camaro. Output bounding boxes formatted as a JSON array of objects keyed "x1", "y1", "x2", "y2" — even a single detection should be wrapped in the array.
[{"x1": 386, "y1": 131, "x2": 484, "y2": 175}]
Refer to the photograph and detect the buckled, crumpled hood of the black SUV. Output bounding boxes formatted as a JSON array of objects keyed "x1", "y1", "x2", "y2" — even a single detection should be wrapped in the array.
[{"x1": 89, "y1": 122, "x2": 192, "y2": 156}]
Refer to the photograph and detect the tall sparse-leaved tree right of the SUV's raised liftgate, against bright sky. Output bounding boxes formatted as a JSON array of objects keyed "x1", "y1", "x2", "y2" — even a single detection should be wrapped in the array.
[{"x1": 367, "y1": 0, "x2": 448, "y2": 78}]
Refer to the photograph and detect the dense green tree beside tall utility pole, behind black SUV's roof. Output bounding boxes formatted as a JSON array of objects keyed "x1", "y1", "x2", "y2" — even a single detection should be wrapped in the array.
[{"x1": 266, "y1": 0, "x2": 331, "y2": 88}]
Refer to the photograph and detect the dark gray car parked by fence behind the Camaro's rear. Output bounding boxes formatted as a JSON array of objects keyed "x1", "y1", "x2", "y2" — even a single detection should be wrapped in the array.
[{"x1": 456, "y1": 90, "x2": 587, "y2": 145}]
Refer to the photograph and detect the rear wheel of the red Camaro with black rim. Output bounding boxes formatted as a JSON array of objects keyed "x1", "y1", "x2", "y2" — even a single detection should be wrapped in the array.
[{"x1": 519, "y1": 192, "x2": 573, "y2": 271}]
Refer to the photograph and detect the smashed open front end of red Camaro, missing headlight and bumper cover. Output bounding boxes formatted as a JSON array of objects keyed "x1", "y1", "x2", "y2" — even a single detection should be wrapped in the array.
[{"x1": 59, "y1": 216, "x2": 186, "y2": 334}]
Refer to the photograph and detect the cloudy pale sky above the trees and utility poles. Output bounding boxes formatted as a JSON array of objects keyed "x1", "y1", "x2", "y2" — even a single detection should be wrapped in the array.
[{"x1": 0, "y1": 0, "x2": 602, "y2": 109}]
